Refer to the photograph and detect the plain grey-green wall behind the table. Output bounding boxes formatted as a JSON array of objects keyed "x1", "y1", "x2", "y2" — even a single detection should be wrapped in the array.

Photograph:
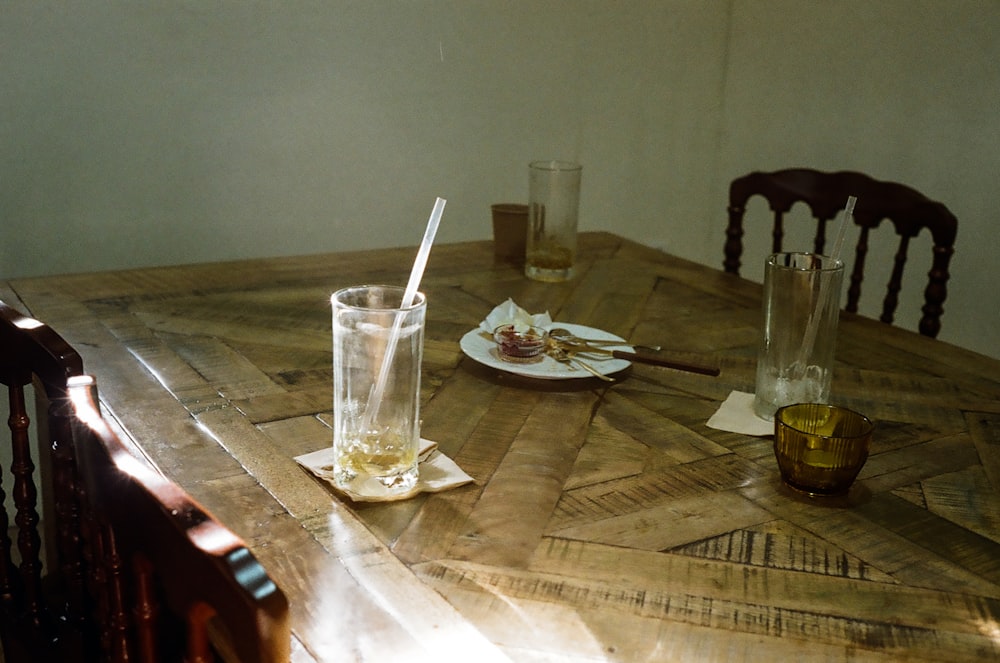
[{"x1": 0, "y1": 0, "x2": 1000, "y2": 357}]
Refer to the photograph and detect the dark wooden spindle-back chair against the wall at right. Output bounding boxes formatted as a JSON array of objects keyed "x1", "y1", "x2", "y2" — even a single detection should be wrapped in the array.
[{"x1": 723, "y1": 168, "x2": 958, "y2": 338}]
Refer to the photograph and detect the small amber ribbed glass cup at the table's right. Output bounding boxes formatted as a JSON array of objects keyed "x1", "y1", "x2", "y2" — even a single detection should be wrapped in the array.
[{"x1": 774, "y1": 403, "x2": 875, "y2": 495}]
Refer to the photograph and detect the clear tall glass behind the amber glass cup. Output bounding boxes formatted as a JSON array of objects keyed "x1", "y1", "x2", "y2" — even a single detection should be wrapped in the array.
[{"x1": 754, "y1": 253, "x2": 844, "y2": 420}]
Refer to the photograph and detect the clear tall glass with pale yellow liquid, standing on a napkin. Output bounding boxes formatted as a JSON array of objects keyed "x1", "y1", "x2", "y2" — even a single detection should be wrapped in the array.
[{"x1": 331, "y1": 285, "x2": 427, "y2": 497}]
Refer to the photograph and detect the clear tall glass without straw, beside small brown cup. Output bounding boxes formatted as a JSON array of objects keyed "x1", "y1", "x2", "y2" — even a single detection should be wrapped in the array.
[{"x1": 524, "y1": 161, "x2": 583, "y2": 281}]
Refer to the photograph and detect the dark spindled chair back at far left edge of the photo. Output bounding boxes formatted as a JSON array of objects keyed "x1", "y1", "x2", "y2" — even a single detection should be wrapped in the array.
[{"x1": 0, "y1": 302, "x2": 85, "y2": 662}]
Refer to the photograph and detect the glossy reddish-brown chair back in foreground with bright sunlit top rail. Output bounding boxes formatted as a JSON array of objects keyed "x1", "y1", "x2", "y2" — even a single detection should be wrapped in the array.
[{"x1": 69, "y1": 376, "x2": 291, "y2": 663}]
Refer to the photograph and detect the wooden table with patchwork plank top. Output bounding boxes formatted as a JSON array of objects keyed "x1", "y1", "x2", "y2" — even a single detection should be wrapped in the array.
[{"x1": 0, "y1": 233, "x2": 1000, "y2": 661}]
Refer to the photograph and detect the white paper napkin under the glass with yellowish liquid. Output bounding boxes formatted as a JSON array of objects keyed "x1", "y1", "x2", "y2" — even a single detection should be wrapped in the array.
[{"x1": 295, "y1": 438, "x2": 473, "y2": 502}]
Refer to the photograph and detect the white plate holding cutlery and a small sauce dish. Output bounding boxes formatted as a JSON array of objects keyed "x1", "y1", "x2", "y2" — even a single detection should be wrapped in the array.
[{"x1": 460, "y1": 322, "x2": 633, "y2": 380}]
